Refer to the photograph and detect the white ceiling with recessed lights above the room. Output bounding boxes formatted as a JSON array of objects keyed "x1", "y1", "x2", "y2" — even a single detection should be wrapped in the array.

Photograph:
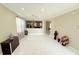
[{"x1": 3, "y1": 3, "x2": 79, "y2": 20}]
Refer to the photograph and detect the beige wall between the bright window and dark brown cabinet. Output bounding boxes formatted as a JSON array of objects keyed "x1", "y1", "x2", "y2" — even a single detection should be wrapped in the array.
[{"x1": 0, "y1": 5, "x2": 16, "y2": 42}]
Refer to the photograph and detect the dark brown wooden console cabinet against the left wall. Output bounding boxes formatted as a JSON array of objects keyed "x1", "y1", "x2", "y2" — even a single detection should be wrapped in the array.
[{"x1": 1, "y1": 36, "x2": 19, "y2": 55}]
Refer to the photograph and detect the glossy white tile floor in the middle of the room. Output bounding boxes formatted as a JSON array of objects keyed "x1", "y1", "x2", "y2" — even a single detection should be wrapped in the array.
[{"x1": 12, "y1": 35, "x2": 76, "y2": 55}]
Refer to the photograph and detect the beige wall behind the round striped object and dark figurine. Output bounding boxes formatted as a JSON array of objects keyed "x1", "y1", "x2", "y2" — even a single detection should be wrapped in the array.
[{"x1": 52, "y1": 9, "x2": 79, "y2": 50}]
